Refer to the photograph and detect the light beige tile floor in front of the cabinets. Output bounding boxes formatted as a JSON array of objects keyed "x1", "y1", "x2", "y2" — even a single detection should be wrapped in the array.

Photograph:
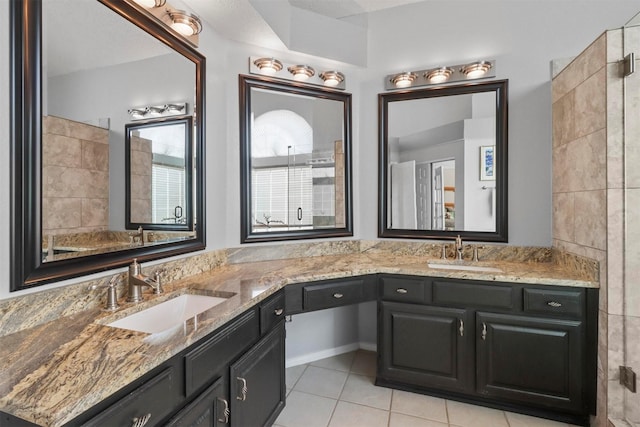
[{"x1": 274, "y1": 350, "x2": 580, "y2": 427}]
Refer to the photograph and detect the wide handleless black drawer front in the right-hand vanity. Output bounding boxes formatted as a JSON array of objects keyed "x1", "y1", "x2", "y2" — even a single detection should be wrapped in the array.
[{"x1": 433, "y1": 280, "x2": 519, "y2": 309}]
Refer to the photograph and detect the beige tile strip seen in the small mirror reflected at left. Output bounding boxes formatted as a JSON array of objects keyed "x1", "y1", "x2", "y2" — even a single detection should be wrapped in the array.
[{"x1": 130, "y1": 135, "x2": 153, "y2": 224}]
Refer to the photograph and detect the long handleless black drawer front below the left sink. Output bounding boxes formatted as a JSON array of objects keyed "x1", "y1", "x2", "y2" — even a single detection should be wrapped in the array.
[{"x1": 184, "y1": 310, "x2": 260, "y2": 396}]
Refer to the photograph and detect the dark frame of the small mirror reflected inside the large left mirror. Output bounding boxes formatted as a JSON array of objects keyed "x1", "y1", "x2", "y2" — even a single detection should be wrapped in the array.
[{"x1": 124, "y1": 116, "x2": 193, "y2": 231}]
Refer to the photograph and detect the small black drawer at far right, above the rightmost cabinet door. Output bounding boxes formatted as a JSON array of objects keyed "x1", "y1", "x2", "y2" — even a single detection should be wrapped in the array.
[{"x1": 524, "y1": 288, "x2": 584, "y2": 317}]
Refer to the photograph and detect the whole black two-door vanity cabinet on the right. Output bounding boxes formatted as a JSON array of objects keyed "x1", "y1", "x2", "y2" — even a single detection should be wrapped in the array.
[{"x1": 376, "y1": 275, "x2": 597, "y2": 424}]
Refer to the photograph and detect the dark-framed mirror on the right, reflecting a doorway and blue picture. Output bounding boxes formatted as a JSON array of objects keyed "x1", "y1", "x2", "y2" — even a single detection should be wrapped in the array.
[{"x1": 378, "y1": 80, "x2": 508, "y2": 242}]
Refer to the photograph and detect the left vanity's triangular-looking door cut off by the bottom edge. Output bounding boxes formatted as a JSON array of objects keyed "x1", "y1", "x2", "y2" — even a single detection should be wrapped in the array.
[{"x1": 167, "y1": 377, "x2": 229, "y2": 427}]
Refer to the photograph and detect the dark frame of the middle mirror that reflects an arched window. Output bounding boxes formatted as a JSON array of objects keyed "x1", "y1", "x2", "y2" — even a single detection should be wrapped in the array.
[{"x1": 239, "y1": 75, "x2": 353, "y2": 243}]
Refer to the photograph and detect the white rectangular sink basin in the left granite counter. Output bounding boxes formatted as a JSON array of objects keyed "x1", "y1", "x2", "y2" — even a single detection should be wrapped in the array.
[{"x1": 107, "y1": 294, "x2": 227, "y2": 334}]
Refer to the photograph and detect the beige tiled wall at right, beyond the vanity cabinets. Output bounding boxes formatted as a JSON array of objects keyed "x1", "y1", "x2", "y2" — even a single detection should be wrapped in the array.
[{"x1": 552, "y1": 30, "x2": 640, "y2": 426}]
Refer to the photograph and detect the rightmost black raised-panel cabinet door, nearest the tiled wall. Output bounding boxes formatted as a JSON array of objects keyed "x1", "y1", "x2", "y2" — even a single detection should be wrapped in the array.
[{"x1": 476, "y1": 313, "x2": 585, "y2": 411}]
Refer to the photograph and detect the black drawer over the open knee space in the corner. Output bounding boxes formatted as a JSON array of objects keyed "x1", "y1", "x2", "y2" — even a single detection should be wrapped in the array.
[{"x1": 302, "y1": 279, "x2": 364, "y2": 310}]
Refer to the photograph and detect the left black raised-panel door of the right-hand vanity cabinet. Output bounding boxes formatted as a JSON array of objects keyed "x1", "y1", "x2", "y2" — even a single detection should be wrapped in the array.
[{"x1": 378, "y1": 302, "x2": 474, "y2": 391}]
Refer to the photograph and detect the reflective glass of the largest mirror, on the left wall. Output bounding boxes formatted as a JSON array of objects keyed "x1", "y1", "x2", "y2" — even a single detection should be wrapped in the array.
[{"x1": 42, "y1": 0, "x2": 196, "y2": 262}]
